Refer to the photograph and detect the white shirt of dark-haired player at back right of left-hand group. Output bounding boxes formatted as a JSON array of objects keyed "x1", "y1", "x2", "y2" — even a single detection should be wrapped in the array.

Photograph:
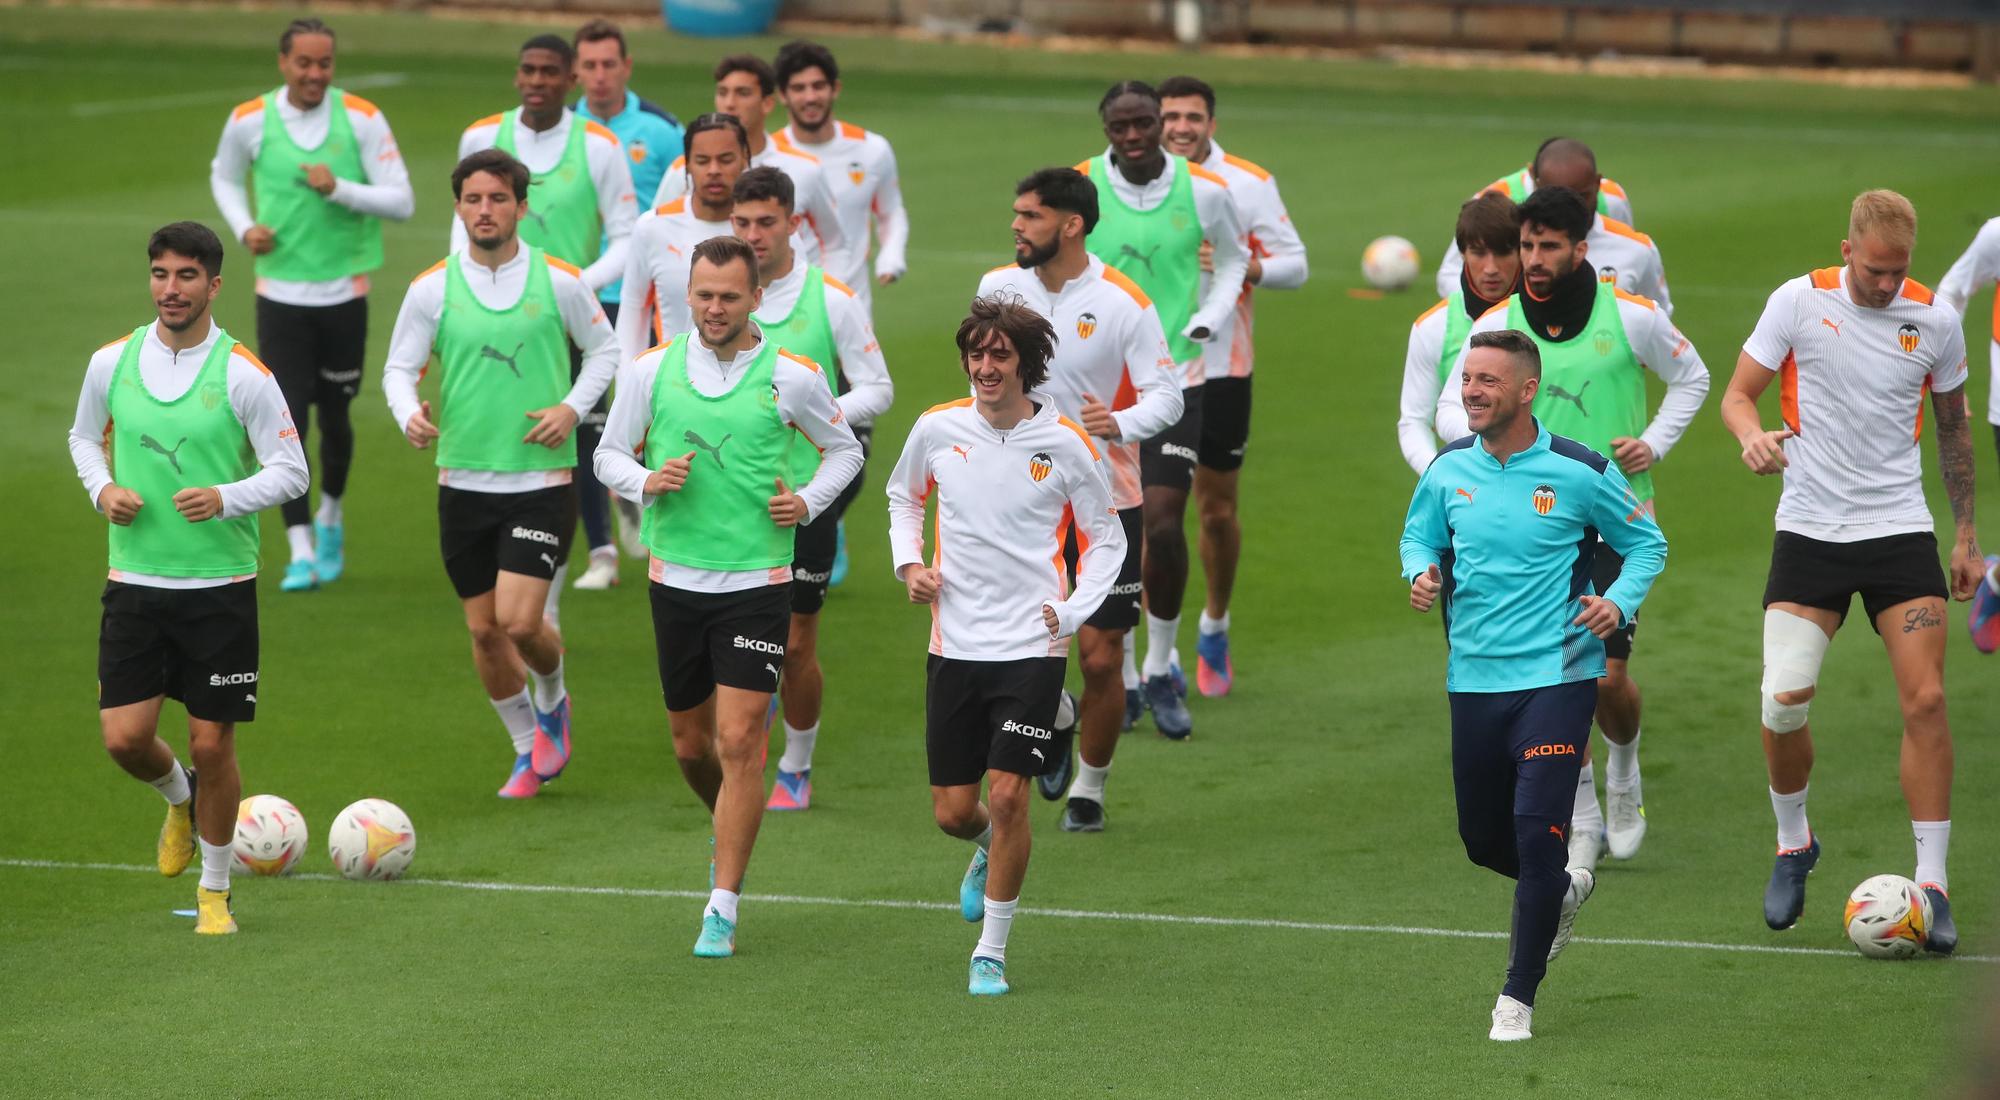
[{"x1": 772, "y1": 122, "x2": 910, "y2": 310}]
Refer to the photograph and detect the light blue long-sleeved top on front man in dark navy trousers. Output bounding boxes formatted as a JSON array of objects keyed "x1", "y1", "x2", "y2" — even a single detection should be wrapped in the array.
[{"x1": 1402, "y1": 420, "x2": 1666, "y2": 692}]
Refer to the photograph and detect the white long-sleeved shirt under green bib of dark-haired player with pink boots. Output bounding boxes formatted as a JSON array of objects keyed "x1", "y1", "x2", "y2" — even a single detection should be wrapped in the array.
[{"x1": 382, "y1": 246, "x2": 618, "y2": 492}]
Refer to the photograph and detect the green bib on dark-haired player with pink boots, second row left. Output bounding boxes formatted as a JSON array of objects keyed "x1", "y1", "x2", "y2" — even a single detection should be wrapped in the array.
[{"x1": 432, "y1": 248, "x2": 576, "y2": 472}]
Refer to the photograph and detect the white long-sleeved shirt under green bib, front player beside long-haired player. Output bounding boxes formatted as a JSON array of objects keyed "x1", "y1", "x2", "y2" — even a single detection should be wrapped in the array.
[{"x1": 592, "y1": 330, "x2": 862, "y2": 592}]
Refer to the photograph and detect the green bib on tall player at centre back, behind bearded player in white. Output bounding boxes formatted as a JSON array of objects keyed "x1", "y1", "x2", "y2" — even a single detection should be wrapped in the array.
[{"x1": 1084, "y1": 154, "x2": 1202, "y2": 362}]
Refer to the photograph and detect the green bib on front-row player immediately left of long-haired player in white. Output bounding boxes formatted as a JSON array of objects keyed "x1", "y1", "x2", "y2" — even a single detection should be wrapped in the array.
[{"x1": 642, "y1": 334, "x2": 798, "y2": 572}]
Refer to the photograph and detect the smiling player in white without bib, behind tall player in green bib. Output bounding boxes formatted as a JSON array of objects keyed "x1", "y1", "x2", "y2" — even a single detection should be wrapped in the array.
[{"x1": 1160, "y1": 76, "x2": 1306, "y2": 696}]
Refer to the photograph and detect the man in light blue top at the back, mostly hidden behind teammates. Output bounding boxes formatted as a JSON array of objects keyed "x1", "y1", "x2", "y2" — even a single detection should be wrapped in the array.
[{"x1": 572, "y1": 20, "x2": 684, "y2": 588}]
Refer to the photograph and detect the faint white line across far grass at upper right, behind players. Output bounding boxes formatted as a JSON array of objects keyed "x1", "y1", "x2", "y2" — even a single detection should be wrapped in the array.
[{"x1": 938, "y1": 96, "x2": 2000, "y2": 148}]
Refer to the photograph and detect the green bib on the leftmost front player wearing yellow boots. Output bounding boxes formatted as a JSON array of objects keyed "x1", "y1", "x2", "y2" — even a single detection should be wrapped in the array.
[{"x1": 106, "y1": 324, "x2": 258, "y2": 576}]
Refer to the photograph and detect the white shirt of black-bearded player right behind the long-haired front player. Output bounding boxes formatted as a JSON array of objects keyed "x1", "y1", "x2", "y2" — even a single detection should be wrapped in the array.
[{"x1": 978, "y1": 256, "x2": 1186, "y2": 508}]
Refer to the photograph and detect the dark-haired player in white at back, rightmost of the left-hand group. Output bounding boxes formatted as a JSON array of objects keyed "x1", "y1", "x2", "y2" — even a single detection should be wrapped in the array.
[{"x1": 772, "y1": 42, "x2": 910, "y2": 310}]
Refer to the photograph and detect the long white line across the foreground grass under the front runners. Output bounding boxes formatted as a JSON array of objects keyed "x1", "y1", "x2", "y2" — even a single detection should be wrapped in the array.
[{"x1": 11, "y1": 858, "x2": 2000, "y2": 962}]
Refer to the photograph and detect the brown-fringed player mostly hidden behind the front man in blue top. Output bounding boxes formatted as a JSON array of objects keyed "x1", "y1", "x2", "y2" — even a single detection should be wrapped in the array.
[{"x1": 1396, "y1": 192, "x2": 1520, "y2": 476}]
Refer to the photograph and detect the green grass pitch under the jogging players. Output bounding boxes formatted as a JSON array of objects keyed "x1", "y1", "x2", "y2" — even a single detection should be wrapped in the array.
[{"x1": 0, "y1": 6, "x2": 2000, "y2": 1096}]
